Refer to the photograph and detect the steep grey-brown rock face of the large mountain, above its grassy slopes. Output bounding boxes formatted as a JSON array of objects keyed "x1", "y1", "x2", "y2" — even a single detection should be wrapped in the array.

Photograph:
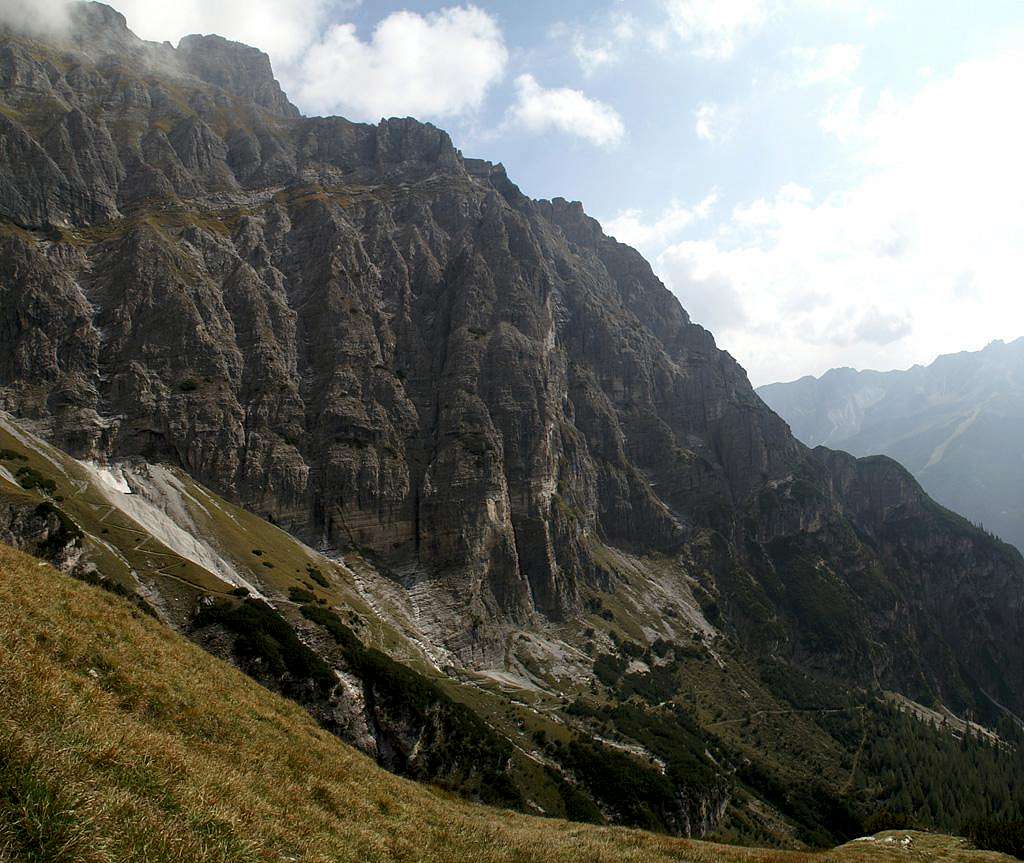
[{"x1": 0, "y1": 7, "x2": 1024, "y2": 706}]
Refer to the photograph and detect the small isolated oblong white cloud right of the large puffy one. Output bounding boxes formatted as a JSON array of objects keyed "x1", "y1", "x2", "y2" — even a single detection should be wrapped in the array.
[{"x1": 506, "y1": 75, "x2": 626, "y2": 146}]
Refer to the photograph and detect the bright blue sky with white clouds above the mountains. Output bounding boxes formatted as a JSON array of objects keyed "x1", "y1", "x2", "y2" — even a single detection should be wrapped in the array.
[{"x1": 68, "y1": 0, "x2": 1024, "y2": 385}]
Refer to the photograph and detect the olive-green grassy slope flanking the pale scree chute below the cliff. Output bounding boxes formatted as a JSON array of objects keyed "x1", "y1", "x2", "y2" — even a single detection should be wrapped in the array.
[{"x1": 0, "y1": 413, "x2": 585, "y2": 814}]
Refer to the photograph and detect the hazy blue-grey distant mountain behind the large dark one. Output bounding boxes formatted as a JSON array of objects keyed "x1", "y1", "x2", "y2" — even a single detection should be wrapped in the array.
[{"x1": 758, "y1": 338, "x2": 1024, "y2": 549}]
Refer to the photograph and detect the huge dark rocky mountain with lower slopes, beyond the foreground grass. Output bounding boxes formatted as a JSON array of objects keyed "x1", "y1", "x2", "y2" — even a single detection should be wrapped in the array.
[{"x1": 0, "y1": 3, "x2": 1024, "y2": 848}]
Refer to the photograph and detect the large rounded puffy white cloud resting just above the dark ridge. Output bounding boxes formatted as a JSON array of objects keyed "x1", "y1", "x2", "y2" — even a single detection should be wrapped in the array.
[{"x1": 287, "y1": 6, "x2": 508, "y2": 120}]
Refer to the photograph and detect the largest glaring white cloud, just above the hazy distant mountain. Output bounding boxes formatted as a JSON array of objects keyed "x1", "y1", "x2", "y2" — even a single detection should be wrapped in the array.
[{"x1": 655, "y1": 50, "x2": 1024, "y2": 383}]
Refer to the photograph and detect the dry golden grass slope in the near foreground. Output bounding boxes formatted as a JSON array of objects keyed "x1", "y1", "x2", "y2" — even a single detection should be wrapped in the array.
[{"x1": 0, "y1": 547, "x2": 1007, "y2": 863}]
